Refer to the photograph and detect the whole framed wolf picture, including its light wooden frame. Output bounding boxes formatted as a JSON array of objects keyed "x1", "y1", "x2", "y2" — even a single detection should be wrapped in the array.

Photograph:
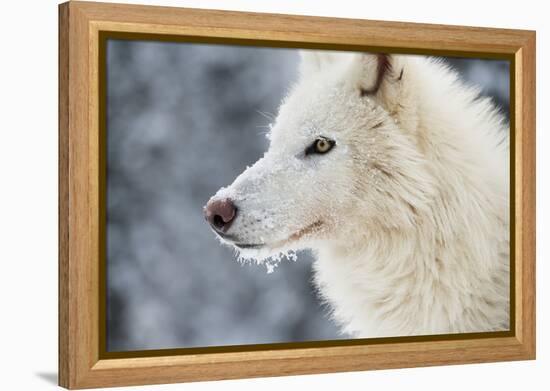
[{"x1": 59, "y1": 1, "x2": 535, "y2": 389}]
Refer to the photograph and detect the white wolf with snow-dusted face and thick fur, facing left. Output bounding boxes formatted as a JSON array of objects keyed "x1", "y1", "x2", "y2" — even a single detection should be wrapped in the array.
[{"x1": 205, "y1": 51, "x2": 509, "y2": 337}]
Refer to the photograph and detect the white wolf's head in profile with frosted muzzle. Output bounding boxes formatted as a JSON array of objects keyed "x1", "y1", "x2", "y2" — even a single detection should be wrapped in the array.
[{"x1": 205, "y1": 51, "x2": 438, "y2": 259}]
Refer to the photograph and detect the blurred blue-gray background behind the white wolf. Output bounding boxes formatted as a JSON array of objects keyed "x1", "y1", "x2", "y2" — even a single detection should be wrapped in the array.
[{"x1": 107, "y1": 40, "x2": 509, "y2": 351}]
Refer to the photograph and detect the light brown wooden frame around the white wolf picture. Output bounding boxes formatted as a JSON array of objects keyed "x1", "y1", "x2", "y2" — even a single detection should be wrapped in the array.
[{"x1": 59, "y1": 1, "x2": 535, "y2": 389}]
